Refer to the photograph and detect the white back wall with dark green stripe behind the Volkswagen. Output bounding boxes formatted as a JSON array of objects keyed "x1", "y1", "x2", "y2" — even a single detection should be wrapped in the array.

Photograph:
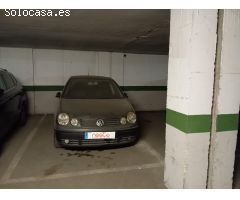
[{"x1": 0, "y1": 47, "x2": 168, "y2": 113}]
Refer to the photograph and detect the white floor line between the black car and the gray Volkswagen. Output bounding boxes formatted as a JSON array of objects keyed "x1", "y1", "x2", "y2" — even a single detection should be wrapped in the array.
[{"x1": 0, "y1": 115, "x2": 46, "y2": 183}]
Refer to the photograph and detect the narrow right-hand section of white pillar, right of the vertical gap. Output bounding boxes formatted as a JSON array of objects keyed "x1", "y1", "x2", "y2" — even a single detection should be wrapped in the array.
[{"x1": 208, "y1": 10, "x2": 240, "y2": 188}]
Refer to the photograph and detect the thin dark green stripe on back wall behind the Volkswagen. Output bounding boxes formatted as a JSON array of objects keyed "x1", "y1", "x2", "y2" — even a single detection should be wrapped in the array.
[{"x1": 23, "y1": 85, "x2": 167, "y2": 91}]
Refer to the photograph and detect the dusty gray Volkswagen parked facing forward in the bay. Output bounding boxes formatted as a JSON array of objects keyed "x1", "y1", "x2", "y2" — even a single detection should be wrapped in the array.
[{"x1": 54, "y1": 76, "x2": 140, "y2": 147}]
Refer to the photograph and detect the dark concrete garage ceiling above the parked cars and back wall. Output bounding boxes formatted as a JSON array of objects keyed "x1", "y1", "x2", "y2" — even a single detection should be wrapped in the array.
[{"x1": 0, "y1": 10, "x2": 170, "y2": 54}]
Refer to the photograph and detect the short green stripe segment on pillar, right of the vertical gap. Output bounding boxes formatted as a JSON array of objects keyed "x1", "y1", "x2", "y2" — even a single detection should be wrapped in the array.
[{"x1": 217, "y1": 114, "x2": 239, "y2": 132}]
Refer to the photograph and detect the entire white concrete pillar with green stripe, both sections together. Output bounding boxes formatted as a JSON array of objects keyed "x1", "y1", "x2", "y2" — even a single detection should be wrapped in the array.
[{"x1": 164, "y1": 10, "x2": 240, "y2": 188}]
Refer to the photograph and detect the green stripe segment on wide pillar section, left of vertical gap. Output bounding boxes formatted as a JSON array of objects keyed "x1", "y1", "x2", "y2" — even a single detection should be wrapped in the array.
[{"x1": 166, "y1": 109, "x2": 211, "y2": 133}]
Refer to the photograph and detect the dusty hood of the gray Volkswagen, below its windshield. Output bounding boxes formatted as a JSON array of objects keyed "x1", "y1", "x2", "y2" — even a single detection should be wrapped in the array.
[{"x1": 59, "y1": 98, "x2": 134, "y2": 117}]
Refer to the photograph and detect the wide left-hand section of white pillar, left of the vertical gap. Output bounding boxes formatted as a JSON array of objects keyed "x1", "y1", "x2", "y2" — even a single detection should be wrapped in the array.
[{"x1": 164, "y1": 10, "x2": 218, "y2": 188}]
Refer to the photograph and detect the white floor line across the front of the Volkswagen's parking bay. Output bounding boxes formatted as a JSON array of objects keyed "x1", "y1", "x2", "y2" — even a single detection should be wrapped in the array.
[{"x1": 1, "y1": 163, "x2": 162, "y2": 184}]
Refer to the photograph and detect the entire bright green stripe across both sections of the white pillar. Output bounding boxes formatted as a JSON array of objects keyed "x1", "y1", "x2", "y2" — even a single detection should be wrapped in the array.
[{"x1": 166, "y1": 108, "x2": 239, "y2": 133}]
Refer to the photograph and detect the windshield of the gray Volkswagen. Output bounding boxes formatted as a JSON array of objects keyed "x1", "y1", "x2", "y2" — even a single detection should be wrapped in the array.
[{"x1": 62, "y1": 78, "x2": 123, "y2": 99}]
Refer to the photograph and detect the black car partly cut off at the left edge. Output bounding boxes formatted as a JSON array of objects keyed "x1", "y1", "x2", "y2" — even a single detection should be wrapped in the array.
[{"x1": 0, "y1": 68, "x2": 28, "y2": 142}]
